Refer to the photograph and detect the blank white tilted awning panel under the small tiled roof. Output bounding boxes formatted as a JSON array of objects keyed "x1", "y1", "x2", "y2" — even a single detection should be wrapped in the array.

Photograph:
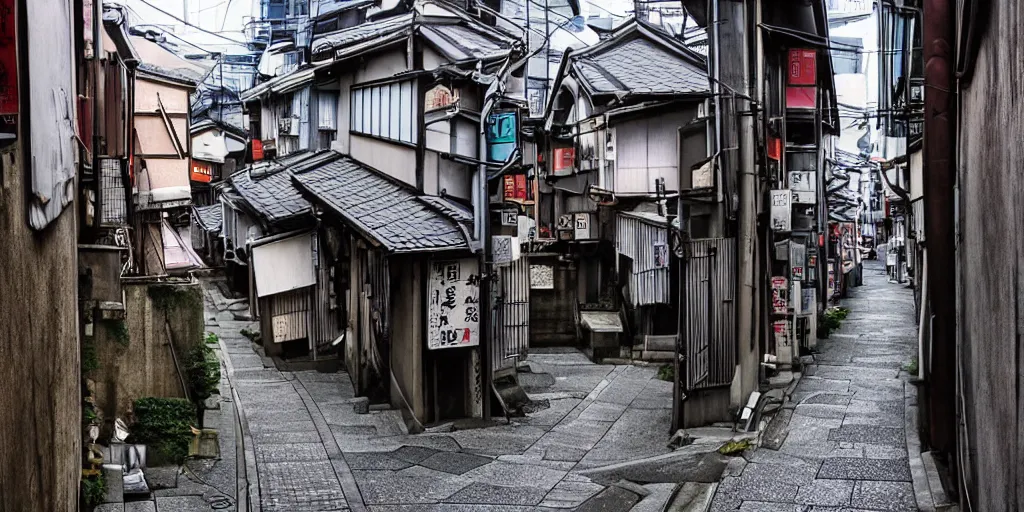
[{"x1": 252, "y1": 232, "x2": 316, "y2": 297}]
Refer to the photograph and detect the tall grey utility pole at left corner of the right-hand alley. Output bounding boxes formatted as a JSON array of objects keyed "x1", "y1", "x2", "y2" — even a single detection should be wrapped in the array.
[{"x1": 712, "y1": 0, "x2": 760, "y2": 402}]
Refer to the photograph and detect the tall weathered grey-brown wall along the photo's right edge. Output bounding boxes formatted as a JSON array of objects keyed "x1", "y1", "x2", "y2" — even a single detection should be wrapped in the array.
[{"x1": 958, "y1": 0, "x2": 1024, "y2": 512}]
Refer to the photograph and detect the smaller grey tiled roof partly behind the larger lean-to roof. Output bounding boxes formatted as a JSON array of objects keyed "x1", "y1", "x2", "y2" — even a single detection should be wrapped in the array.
[{"x1": 230, "y1": 151, "x2": 340, "y2": 223}]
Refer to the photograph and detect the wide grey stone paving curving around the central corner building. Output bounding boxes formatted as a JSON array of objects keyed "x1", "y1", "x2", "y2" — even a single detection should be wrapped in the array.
[{"x1": 198, "y1": 283, "x2": 700, "y2": 512}]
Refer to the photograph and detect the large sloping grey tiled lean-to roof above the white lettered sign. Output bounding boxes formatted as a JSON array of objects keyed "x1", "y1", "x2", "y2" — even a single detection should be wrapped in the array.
[{"x1": 294, "y1": 155, "x2": 468, "y2": 253}]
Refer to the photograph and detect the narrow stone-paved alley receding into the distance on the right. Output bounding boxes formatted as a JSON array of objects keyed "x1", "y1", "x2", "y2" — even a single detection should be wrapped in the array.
[{"x1": 712, "y1": 261, "x2": 918, "y2": 512}]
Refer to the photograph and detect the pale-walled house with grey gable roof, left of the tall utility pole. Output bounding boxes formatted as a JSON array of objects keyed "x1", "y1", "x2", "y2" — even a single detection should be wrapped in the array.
[{"x1": 529, "y1": 20, "x2": 710, "y2": 357}]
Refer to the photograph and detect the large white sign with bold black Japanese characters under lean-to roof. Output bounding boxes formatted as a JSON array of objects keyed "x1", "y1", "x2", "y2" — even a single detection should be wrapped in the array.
[{"x1": 427, "y1": 258, "x2": 480, "y2": 350}]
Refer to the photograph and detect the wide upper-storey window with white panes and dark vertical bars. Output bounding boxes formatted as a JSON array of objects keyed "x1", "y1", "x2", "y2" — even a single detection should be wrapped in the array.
[{"x1": 351, "y1": 81, "x2": 419, "y2": 144}]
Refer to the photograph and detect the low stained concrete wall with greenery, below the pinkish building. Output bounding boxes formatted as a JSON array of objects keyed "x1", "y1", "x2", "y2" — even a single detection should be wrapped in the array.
[{"x1": 86, "y1": 283, "x2": 204, "y2": 423}]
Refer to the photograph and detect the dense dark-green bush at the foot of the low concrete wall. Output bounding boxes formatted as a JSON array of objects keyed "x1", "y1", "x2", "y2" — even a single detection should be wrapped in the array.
[{"x1": 128, "y1": 397, "x2": 197, "y2": 465}]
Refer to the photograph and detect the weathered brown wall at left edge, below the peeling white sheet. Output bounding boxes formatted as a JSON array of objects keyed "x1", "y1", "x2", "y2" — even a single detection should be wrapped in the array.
[{"x1": 0, "y1": 146, "x2": 82, "y2": 512}]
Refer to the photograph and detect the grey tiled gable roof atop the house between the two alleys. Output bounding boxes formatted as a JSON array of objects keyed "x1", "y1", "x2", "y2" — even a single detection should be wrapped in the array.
[{"x1": 572, "y1": 37, "x2": 710, "y2": 94}]
